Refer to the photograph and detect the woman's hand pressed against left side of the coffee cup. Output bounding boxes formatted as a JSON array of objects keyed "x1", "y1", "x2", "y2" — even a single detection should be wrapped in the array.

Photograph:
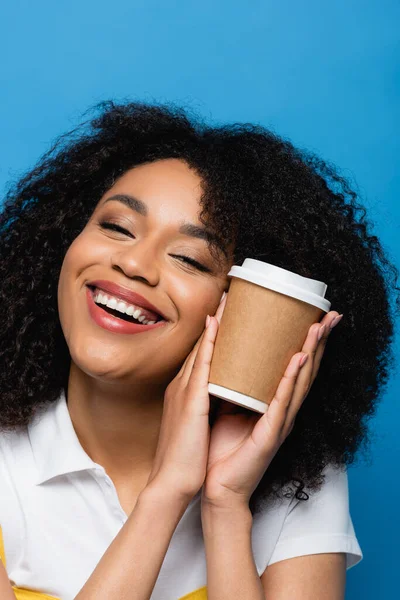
[{"x1": 146, "y1": 296, "x2": 226, "y2": 502}]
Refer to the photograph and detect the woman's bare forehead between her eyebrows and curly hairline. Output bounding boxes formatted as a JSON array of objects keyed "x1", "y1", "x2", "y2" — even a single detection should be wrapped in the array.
[{"x1": 100, "y1": 158, "x2": 202, "y2": 220}]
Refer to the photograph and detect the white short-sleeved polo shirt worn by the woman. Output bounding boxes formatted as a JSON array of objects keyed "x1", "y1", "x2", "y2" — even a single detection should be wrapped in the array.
[{"x1": 0, "y1": 393, "x2": 363, "y2": 600}]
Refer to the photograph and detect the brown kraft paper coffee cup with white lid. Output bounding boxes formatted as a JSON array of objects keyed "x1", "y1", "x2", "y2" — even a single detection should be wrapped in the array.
[{"x1": 208, "y1": 258, "x2": 331, "y2": 413}]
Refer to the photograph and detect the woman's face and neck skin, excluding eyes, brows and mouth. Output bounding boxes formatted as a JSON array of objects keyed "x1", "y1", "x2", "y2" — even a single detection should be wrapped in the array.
[{"x1": 58, "y1": 159, "x2": 231, "y2": 514}]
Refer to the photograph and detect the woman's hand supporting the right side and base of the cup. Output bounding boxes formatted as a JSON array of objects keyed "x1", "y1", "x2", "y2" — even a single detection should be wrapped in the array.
[{"x1": 202, "y1": 298, "x2": 340, "y2": 510}]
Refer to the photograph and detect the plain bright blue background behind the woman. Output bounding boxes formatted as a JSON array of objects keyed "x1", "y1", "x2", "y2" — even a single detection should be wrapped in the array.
[{"x1": 0, "y1": 0, "x2": 400, "y2": 600}]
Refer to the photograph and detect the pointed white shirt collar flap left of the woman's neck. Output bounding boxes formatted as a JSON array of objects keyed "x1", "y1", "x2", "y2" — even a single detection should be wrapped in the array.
[{"x1": 28, "y1": 390, "x2": 99, "y2": 485}]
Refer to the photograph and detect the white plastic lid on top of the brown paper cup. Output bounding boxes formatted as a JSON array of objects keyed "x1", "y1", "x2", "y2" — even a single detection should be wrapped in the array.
[{"x1": 228, "y1": 258, "x2": 331, "y2": 312}]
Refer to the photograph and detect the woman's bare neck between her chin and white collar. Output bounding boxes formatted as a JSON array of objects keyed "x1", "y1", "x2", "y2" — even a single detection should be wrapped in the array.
[{"x1": 67, "y1": 362, "x2": 165, "y2": 487}]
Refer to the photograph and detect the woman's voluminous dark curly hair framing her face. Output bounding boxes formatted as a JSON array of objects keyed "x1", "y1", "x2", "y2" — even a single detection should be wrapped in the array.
[{"x1": 0, "y1": 101, "x2": 400, "y2": 514}]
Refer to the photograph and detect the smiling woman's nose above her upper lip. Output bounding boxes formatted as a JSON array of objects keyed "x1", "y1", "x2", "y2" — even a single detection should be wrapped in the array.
[{"x1": 111, "y1": 239, "x2": 160, "y2": 286}]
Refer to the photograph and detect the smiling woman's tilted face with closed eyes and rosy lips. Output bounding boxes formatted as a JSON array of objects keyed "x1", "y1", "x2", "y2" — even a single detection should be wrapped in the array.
[{"x1": 58, "y1": 159, "x2": 233, "y2": 384}]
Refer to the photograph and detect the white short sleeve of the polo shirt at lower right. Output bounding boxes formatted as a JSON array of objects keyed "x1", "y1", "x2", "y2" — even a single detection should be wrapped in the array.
[{"x1": 268, "y1": 465, "x2": 363, "y2": 570}]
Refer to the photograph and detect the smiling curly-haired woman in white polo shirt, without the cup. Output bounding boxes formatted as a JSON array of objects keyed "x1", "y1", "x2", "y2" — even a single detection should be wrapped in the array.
[{"x1": 0, "y1": 103, "x2": 398, "y2": 600}]
